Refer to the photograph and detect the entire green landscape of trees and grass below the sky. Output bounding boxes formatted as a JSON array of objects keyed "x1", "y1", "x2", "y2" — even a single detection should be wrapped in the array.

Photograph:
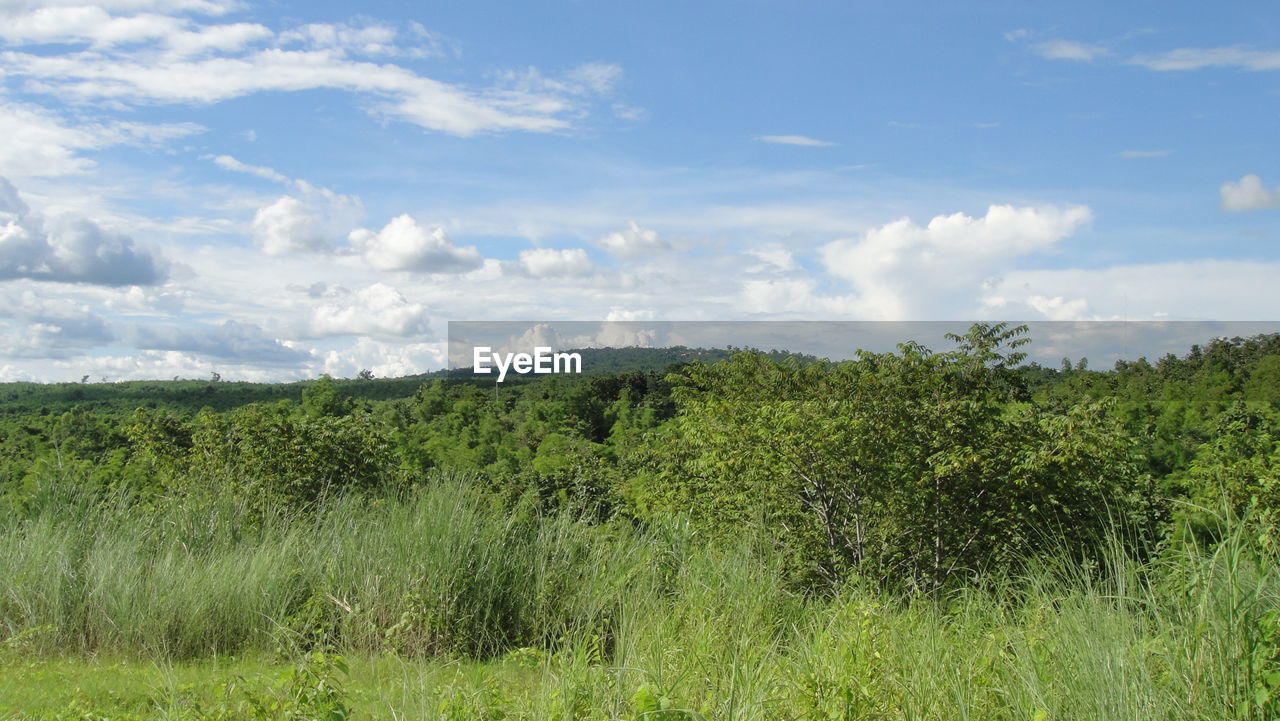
[{"x1": 0, "y1": 323, "x2": 1280, "y2": 721}]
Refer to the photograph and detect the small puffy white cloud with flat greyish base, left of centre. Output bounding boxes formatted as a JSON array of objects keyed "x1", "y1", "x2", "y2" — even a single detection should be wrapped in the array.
[{"x1": 348, "y1": 215, "x2": 484, "y2": 273}]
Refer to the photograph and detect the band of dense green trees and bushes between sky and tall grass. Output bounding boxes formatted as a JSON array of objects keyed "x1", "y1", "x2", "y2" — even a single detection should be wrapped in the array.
[{"x1": 10, "y1": 324, "x2": 1280, "y2": 581}]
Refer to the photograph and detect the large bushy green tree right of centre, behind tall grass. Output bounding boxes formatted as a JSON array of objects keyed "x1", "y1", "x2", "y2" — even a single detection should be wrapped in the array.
[{"x1": 649, "y1": 324, "x2": 1138, "y2": 590}]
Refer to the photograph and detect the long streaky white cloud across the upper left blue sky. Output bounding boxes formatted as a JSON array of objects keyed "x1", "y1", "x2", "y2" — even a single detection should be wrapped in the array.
[{"x1": 0, "y1": 5, "x2": 621, "y2": 136}]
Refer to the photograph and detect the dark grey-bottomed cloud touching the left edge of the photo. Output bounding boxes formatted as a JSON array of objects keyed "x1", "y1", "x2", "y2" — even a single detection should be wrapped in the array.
[{"x1": 0, "y1": 178, "x2": 168, "y2": 286}]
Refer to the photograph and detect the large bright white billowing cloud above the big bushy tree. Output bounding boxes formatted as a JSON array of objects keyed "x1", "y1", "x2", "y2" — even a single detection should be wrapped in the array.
[{"x1": 819, "y1": 205, "x2": 1092, "y2": 320}]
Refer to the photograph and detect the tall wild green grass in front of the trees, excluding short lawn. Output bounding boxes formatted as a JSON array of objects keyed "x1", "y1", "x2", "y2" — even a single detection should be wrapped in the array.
[{"x1": 0, "y1": 475, "x2": 1280, "y2": 721}]
